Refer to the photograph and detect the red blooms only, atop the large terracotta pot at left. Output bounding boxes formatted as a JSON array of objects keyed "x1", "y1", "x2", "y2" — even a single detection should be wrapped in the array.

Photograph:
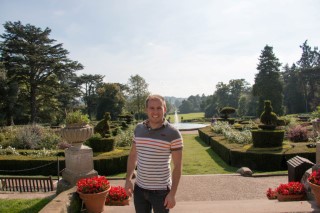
[{"x1": 77, "y1": 176, "x2": 110, "y2": 194}]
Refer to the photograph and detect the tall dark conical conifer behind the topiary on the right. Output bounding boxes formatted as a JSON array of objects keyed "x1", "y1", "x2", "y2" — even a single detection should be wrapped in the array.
[{"x1": 253, "y1": 45, "x2": 283, "y2": 115}]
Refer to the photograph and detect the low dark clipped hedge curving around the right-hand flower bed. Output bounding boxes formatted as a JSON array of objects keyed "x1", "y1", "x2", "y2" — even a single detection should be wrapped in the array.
[{"x1": 198, "y1": 127, "x2": 316, "y2": 171}]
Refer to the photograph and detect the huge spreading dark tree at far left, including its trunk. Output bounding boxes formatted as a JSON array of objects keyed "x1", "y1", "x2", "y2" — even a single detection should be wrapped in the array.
[{"x1": 0, "y1": 21, "x2": 83, "y2": 123}]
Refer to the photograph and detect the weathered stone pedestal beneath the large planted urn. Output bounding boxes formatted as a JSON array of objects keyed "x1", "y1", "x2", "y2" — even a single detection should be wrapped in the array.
[{"x1": 62, "y1": 145, "x2": 98, "y2": 185}]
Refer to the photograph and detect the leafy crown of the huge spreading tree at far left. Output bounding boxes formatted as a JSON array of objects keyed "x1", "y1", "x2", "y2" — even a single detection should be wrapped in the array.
[{"x1": 0, "y1": 21, "x2": 83, "y2": 123}]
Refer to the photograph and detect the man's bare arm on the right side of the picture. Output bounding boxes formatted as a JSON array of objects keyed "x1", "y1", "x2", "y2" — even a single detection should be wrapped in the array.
[{"x1": 164, "y1": 149, "x2": 182, "y2": 209}]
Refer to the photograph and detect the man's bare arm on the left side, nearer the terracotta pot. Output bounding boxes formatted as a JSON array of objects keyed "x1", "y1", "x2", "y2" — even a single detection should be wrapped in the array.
[{"x1": 125, "y1": 143, "x2": 137, "y2": 197}]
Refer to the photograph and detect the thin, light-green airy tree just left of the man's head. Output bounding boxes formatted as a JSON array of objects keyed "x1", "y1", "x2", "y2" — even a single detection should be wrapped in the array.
[{"x1": 127, "y1": 75, "x2": 150, "y2": 119}]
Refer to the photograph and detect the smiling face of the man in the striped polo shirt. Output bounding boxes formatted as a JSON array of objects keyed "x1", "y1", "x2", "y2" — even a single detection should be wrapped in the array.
[{"x1": 147, "y1": 99, "x2": 167, "y2": 124}]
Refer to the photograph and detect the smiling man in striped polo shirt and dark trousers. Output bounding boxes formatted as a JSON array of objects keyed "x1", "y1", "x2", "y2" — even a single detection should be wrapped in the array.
[{"x1": 125, "y1": 95, "x2": 183, "y2": 213}]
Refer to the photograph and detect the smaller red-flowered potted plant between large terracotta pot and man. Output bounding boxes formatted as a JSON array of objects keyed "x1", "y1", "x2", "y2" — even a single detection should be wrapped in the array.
[{"x1": 106, "y1": 186, "x2": 129, "y2": 206}]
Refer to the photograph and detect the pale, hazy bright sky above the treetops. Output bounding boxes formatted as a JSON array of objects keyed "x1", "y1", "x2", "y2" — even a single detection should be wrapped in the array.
[{"x1": 0, "y1": 0, "x2": 320, "y2": 98}]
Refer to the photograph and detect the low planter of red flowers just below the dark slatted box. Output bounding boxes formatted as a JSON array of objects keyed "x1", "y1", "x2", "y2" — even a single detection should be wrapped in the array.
[{"x1": 276, "y1": 181, "x2": 306, "y2": 201}]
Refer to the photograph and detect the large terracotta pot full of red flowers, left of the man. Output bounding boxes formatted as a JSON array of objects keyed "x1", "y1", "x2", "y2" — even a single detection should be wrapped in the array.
[{"x1": 77, "y1": 176, "x2": 110, "y2": 213}]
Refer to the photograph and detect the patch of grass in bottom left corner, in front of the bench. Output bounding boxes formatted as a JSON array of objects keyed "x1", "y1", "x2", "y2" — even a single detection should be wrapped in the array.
[{"x1": 0, "y1": 198, "x2": 51, "y2": 213}]
